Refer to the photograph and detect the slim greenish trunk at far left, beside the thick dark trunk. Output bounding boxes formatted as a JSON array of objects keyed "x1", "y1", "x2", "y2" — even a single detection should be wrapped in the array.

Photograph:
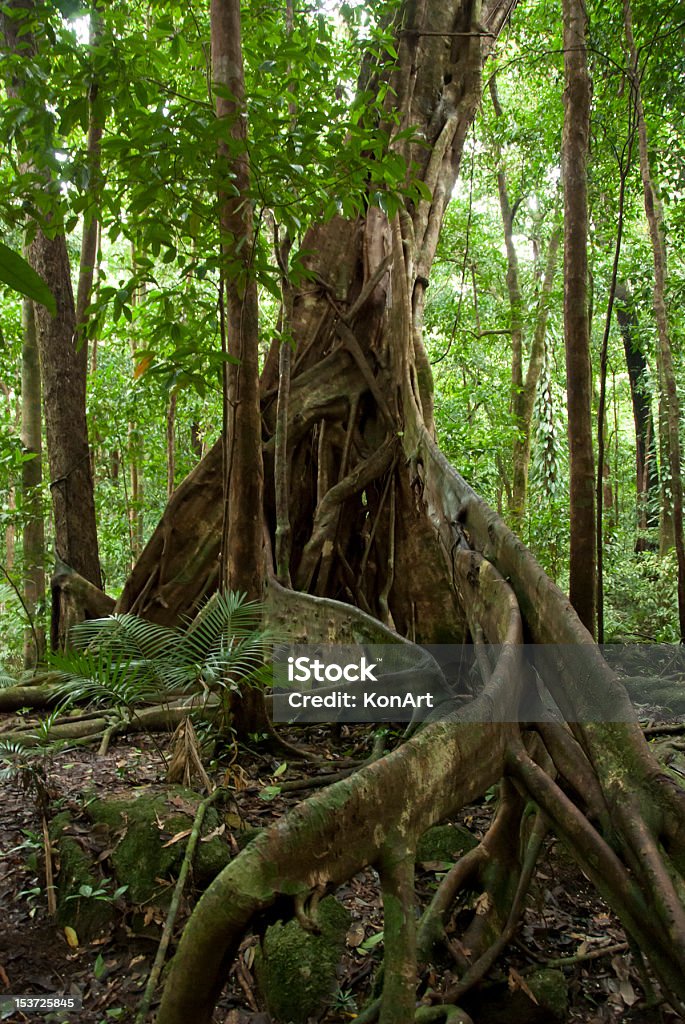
[{"x1": 22, "y1": 299, "x2": 45, "y2": 669}]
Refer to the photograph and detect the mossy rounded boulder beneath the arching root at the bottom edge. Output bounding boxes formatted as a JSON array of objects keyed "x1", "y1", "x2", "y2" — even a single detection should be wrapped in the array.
[{"x1": 255, "y1": 896, "x2": 351, "y2": 1024}]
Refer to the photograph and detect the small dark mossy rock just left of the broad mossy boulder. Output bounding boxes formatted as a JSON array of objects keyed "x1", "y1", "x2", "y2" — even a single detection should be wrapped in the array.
[{"x1": 49, "y1": 811, "x2": 116, "y2": 942}]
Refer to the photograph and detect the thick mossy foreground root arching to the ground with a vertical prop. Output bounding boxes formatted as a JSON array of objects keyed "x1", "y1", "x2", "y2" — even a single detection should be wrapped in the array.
[{"x1": 158, "y1": 553, "x2": 521, "y2": 1024}]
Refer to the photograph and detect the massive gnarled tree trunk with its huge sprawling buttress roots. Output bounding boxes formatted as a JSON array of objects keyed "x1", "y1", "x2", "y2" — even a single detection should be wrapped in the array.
[{"x1": 111, "y1": 0, "x2": 685, "y2": 1024}]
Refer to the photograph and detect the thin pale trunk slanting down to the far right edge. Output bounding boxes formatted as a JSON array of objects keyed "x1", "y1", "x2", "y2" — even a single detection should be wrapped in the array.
[{"x1": 624, "y1": 0, "x2": 685, "y2": 643}]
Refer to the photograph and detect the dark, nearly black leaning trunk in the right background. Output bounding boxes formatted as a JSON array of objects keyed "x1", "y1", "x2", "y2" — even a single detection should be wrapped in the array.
[{"x1": 615, "y1": 282, "x2": 658, "y2": 551}]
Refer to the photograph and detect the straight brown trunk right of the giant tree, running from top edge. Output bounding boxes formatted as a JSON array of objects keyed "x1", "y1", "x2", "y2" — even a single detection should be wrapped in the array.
[{"x1": 562, "y1": 0, "x2": 596, "y2": 636}]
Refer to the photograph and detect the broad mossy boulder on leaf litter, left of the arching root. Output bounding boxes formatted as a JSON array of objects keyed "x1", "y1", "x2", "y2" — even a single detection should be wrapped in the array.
[{"x1": 86, "y1": 786, "x2": 230, "y2": 903}]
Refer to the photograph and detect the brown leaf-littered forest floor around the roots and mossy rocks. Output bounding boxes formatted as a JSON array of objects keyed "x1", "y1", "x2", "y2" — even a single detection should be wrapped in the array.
[{"x1": 0, "y1": 722, "x2": 679, "y2": 1024}]
